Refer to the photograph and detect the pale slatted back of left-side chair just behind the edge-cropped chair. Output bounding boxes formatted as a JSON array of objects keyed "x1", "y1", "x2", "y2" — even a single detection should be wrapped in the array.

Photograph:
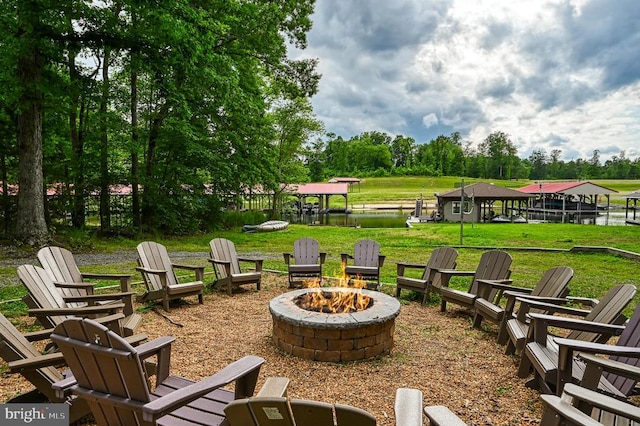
[{"x1": 18, "y1": 265, "x2": 70, "y2": 326}]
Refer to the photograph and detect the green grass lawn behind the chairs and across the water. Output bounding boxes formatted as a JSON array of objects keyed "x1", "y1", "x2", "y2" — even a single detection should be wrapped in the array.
[{"x1": 0, "y1": 177, "x2": 640, "y2": 316}]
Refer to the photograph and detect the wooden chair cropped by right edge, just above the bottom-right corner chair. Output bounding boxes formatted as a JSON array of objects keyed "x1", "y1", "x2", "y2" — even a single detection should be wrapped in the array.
[{"x1": 548, "y1": 305, "x2": 640, "y2": 398}]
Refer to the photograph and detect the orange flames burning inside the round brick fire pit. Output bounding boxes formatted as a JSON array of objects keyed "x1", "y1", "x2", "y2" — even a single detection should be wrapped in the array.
[{"x1": 296, "y1": 265, "x2": 371, "y2": 314}]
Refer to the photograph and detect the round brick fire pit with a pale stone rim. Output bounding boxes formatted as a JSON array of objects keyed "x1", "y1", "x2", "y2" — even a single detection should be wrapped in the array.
[{"x1": 269, "y1": 287, "x2": 400, "y2": 362}]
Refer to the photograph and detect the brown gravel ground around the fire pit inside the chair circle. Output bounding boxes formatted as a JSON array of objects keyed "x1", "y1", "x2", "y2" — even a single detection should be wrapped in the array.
[{"x1": 0, "y1": 266, "x2": 541, "y2": 426}]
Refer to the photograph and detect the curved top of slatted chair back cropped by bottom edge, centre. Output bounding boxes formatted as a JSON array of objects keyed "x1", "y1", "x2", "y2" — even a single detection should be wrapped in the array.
[{"x1": 224, "y1": 397, "x2": 376, "y2": 426}]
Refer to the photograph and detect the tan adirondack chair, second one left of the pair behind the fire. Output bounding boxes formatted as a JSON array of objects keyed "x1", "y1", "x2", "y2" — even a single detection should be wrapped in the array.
[{"x1": 136, "y1": 241, "x2": 204, "y2": 312}]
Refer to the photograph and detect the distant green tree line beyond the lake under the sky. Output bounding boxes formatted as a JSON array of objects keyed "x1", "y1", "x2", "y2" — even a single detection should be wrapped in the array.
[{"x1": 307, "y1": 131, "x2": 640, "y2": 181}]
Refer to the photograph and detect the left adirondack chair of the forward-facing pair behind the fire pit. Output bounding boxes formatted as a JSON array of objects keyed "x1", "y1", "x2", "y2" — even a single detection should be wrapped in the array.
[{"x1": 283, "y1": 237, "x2": 327, "y2": 288}]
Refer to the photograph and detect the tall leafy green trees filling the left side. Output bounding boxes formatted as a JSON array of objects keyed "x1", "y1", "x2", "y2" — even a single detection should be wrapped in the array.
[{"x1": 0, "y1": 0, "x2": 321, "y2": 245}]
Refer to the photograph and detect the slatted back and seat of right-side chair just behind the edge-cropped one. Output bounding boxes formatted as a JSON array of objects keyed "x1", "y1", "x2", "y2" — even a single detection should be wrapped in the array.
[{"x1": 567, "y1": 284, "x2": 636, "y2": 343}]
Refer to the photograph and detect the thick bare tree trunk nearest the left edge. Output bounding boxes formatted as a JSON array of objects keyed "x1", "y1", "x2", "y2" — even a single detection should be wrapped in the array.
[{"x1": 15, "y1": 1, "x2": 48, "y2": 246}]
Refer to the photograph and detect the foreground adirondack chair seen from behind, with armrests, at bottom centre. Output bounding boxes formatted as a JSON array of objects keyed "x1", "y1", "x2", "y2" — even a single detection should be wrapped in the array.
[{"x1": 224, "y1": 377, "x2": 422, "y2": 426}]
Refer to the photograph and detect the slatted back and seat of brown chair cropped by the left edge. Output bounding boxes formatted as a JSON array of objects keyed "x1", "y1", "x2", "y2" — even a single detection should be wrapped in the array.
[{"x1": 0, "y1": 314, "x2": 63, "y2": 402}]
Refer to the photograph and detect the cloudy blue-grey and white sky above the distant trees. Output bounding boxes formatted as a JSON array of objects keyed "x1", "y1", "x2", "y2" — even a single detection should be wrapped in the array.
[{"x1": 290, "y1": 0, "x2": 640, "y2": 162}]
